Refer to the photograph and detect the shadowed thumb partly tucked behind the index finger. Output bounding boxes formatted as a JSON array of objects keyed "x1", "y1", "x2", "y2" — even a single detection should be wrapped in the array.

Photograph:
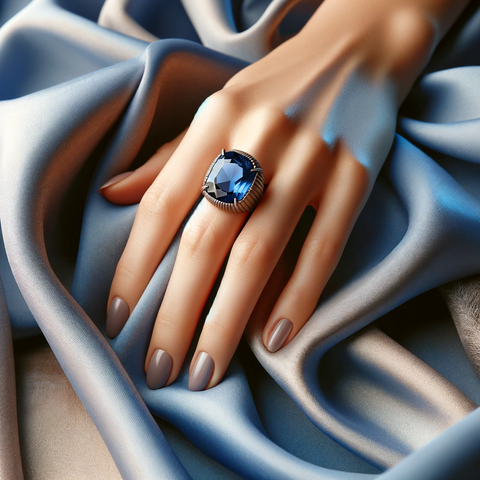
[{"x1": 98, "y1": 128, "x2": 188, "y2": 205}]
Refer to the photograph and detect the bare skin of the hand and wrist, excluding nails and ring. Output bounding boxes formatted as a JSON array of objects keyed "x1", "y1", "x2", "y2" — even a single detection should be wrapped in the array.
[{"x1": 101, "y1": 0, "x2": 467, "y2": 388}]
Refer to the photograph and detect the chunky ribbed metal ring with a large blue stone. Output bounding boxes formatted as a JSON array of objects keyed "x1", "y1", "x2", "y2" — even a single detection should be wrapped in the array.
[{"x1": 202, "y1": 149, "x2": 264, "y2": 213}]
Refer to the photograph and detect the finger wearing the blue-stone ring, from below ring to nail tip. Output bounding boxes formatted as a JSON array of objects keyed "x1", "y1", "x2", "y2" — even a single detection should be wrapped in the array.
[{"x1": 145, "y1": 198, "x2": 248, "y2": 389}]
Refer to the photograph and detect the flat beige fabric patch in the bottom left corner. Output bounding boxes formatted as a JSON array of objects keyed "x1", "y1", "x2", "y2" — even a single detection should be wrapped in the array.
[{"x1": 14, "y1": 337, "x2": 121, "y2": 480}]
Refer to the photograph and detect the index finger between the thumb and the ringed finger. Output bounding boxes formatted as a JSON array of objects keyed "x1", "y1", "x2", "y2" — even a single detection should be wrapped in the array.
[{"x1": 106, "y1": 98, "x2": 232, "y2": 338}]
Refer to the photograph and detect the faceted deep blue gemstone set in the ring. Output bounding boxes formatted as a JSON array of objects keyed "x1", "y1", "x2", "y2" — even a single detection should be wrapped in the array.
[{"x1": 206, "y1": 151, "x2": 256, "y2": 203}]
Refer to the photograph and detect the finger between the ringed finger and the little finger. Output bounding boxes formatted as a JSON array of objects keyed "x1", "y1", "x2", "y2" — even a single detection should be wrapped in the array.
[{"x1": 185, "y1": 134, "x2": 324, "y2": 390}]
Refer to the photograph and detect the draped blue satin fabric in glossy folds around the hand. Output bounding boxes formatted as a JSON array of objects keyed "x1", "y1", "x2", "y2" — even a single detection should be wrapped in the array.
[{"x1": 0, "y1": 0, "x2": 480, "y2": 480}]
